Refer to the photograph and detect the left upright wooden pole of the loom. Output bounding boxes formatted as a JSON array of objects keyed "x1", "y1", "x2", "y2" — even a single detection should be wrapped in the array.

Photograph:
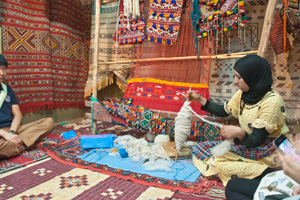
[{"x1": 91, "y1": 0, "x2": 101, "y2": 134}]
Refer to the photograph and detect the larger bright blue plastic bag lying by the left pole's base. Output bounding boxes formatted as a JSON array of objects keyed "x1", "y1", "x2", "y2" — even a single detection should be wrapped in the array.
[{"x1": 80, "y1": 134, "x2": 116, "y2": 149}]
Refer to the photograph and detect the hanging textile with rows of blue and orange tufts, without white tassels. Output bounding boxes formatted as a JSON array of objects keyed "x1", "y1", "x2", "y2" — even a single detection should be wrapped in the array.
[{"x1": 147, "y1": 0, "x2": 183, "y2": 45}]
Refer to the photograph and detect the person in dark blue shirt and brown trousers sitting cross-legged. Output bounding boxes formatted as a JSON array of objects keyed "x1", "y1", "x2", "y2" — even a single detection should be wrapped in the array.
[{"x1": 0, "y1": 54, "x2": 55, "y2": 159}]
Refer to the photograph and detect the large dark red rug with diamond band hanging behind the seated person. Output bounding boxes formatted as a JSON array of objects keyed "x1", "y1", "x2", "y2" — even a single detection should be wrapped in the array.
[{"x1": 0, "y1": 0, "x2": 91, "y2": 113}]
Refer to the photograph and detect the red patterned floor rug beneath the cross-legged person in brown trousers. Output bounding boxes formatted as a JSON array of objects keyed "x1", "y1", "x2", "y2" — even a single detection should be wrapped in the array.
[{"x1": 0, "y1": 125, "x2": 70, "y2": 174}]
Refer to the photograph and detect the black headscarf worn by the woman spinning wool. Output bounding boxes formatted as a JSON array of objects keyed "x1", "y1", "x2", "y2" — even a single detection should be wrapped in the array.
[{"x1": 233, "y1": 55, "x2": 273, "y2": 104}]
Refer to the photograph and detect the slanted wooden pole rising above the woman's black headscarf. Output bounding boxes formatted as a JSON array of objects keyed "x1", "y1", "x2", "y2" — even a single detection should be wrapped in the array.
[{"x1": 257, "y1": 0, "x2": 277, "y2": 57}]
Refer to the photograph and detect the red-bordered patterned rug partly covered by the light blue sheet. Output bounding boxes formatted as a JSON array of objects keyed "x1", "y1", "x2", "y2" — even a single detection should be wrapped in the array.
[{"x1": 41, "y1": 134, "x2": 224, "y2": 194}]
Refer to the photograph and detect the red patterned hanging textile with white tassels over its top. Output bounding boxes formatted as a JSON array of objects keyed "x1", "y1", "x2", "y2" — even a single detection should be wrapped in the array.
[{"x1": 117, "y1": 0, "x2": 145, "y2": 45}]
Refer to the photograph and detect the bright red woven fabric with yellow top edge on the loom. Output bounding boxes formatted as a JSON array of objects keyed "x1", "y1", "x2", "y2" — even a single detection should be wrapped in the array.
[{"x1": 124, "y1": 78, "x2": 209, "y2": 115}]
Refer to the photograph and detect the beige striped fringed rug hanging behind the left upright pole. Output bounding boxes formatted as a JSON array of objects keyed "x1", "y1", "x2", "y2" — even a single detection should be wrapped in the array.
[{"x1": 84, "y1": 1, "x2": 133, "y2": 96}]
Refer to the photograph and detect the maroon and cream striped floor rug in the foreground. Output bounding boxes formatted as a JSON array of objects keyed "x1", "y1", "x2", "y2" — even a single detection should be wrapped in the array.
[{"x1": 0, "y1": 159, "x2": 225, "y2": 200}]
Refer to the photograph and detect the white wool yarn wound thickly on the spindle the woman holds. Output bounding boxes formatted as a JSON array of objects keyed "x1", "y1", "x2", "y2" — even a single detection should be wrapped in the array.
[{"x1": 174, "y1": 101, "x2": 192, "y2": 153}]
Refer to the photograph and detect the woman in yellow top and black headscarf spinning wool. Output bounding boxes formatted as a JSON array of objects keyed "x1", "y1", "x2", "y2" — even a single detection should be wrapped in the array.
[{"x1": 186, "y1": 55, "x2": 288, "y2": 199}]
